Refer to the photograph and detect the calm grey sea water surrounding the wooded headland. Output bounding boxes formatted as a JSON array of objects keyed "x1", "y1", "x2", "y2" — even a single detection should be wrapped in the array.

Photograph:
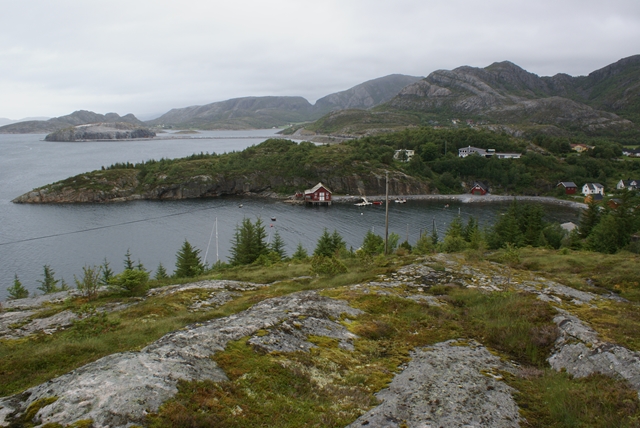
[{"x1": 0, "y1": 130, "x2": 577, "y2": 300}]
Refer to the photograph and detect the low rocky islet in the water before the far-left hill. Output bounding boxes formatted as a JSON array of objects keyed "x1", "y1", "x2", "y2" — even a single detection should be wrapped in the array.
[{"x1": 45, "y1": 122, "x2": 156, "y2": 141}]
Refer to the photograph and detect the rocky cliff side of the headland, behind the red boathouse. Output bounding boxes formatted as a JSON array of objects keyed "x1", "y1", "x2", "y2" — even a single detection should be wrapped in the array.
[{"x1": 13, "y1": 169, "x2": 432, "y2": 204}]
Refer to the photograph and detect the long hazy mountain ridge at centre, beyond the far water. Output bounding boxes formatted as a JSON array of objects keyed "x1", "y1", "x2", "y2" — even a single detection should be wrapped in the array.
[{"x1": 146, "y1": 74, "x2": 420, "y2": 129}]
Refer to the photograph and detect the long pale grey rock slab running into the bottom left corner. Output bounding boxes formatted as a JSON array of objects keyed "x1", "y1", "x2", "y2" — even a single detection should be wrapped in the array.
[{"x1": 0, "y1": 291, "x2": 360, "y2": 428}]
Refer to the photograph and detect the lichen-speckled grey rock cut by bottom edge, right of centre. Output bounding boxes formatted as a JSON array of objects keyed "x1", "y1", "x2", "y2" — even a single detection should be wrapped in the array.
[{"x1": 349, "y1": 340, "x2": 520, "y2": 428}]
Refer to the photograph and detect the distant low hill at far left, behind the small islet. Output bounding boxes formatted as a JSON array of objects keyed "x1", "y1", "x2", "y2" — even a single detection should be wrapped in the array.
[{"x1": 0, "y1": 110, "x2": 144, "y2": 134}]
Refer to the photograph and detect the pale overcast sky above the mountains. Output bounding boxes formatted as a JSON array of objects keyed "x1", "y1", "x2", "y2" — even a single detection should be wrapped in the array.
[{"x1": 0, "y1": 0, "x2": 640, "y2": 119}]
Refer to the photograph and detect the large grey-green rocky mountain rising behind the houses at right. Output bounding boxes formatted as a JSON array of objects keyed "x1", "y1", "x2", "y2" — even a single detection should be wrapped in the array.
[{"x1": 379, "y1": 56, "x2": 640, "y2": 133}]
